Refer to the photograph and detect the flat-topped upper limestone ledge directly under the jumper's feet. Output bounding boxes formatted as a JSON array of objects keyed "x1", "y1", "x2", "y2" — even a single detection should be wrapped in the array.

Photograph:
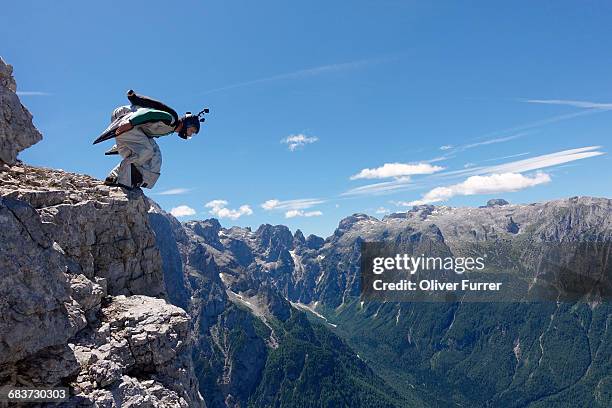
[{"x1": 0, "y1": 165, "x2": 165, "y2": 297}]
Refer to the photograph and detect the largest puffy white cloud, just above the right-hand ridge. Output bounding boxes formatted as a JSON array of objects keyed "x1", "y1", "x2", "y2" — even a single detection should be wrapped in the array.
[{"x1": 400, "y1": 173, "x2": 550, "y2": 206}]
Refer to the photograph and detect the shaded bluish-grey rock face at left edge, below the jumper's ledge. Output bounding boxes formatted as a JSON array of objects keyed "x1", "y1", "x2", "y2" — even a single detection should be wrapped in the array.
[{"x1": 0, "y1": 198, "x2": 84, "y2": 366}]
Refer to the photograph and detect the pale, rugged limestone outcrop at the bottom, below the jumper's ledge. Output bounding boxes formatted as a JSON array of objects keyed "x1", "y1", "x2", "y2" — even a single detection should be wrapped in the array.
[{"x1": 65, "y1": 295, "x2": 200, "y2": 407}]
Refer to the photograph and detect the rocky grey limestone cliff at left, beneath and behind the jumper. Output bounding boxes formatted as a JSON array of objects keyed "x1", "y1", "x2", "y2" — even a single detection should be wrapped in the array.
[{"x1": 0, "y1": 61, "x2": 204, "y2": 407}]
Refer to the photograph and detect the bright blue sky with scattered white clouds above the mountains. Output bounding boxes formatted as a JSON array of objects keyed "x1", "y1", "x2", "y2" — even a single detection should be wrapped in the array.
[{"x1": 0, "y1": 0, "x2": 612, "y2": 236}]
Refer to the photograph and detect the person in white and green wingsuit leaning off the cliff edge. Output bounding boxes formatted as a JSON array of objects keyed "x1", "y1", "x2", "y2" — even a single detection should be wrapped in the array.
[{"x1": 94, "y1": 90, "x2": 209, "y2": 189}]
